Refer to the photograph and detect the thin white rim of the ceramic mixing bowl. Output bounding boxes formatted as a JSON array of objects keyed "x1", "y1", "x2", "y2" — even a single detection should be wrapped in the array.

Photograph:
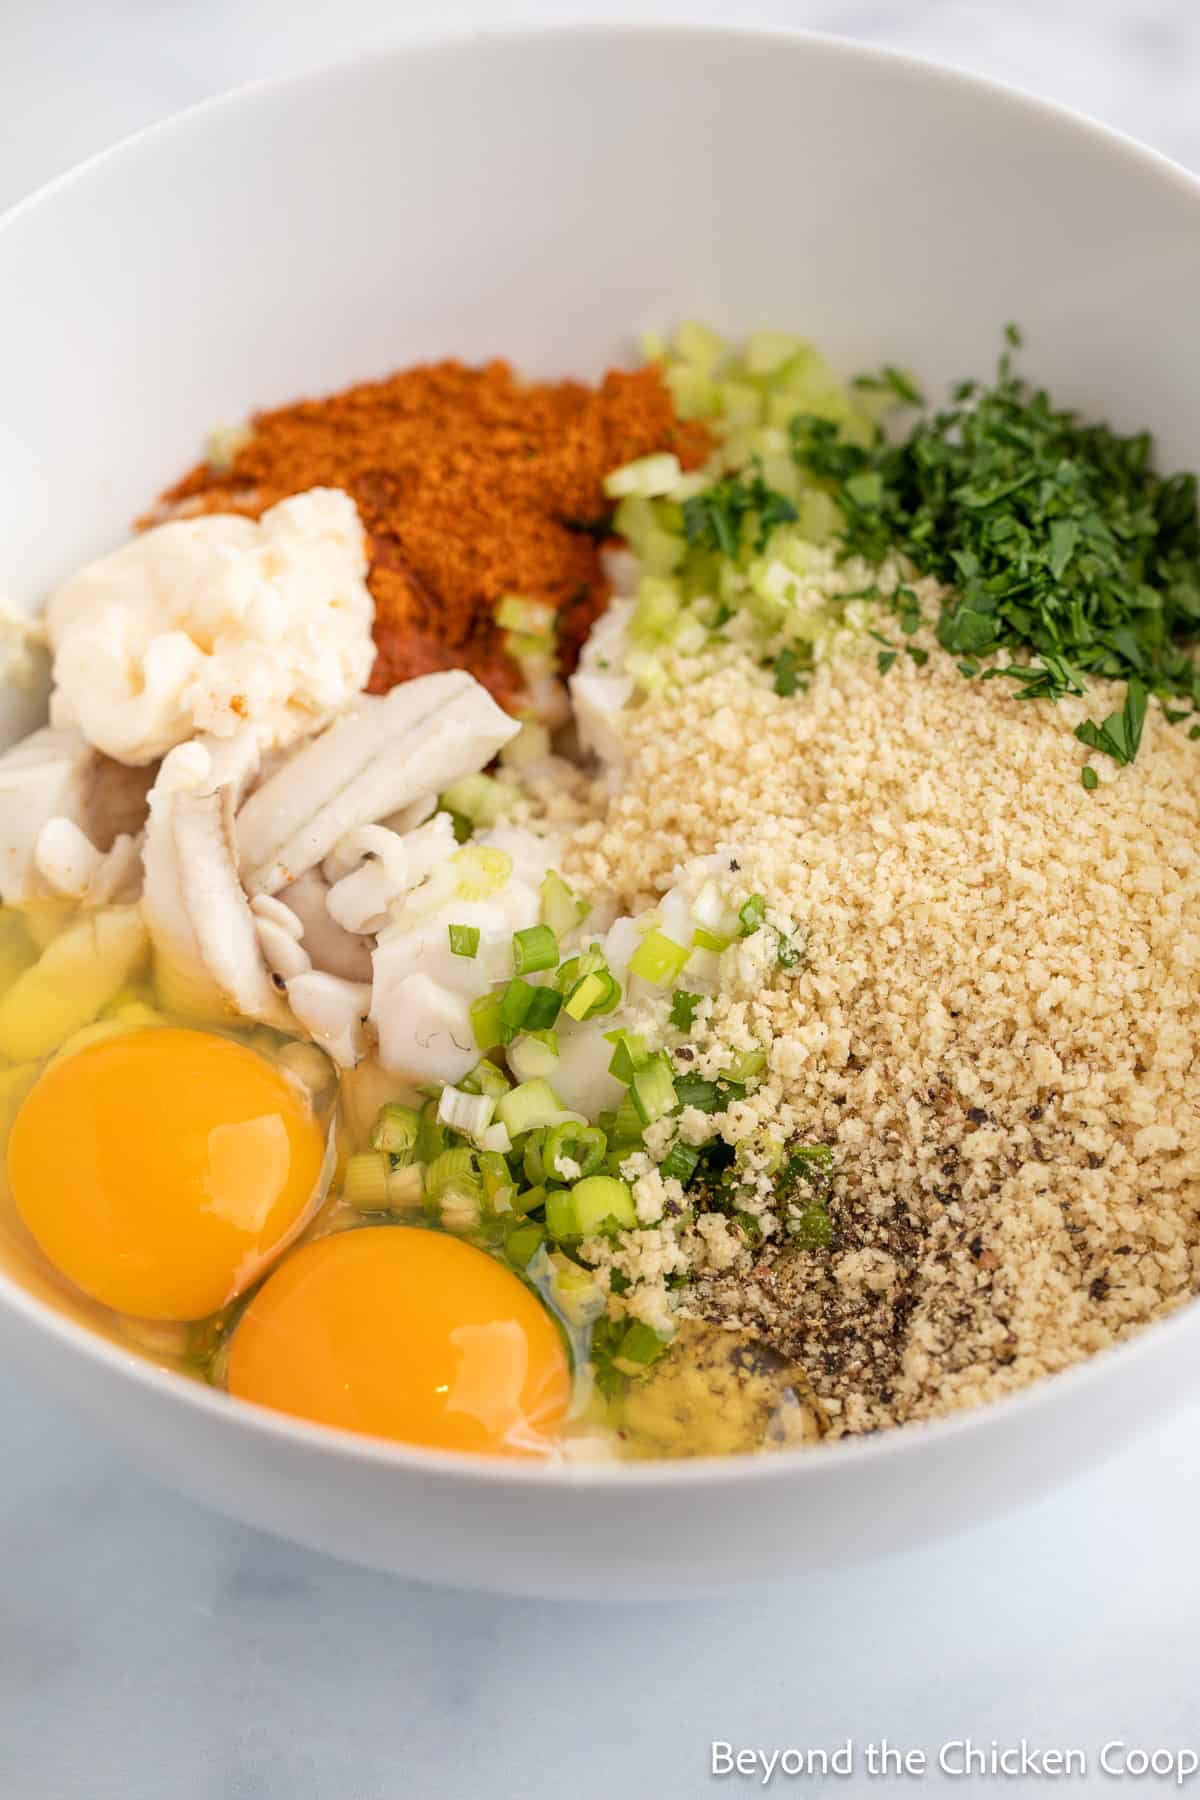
[{"x1": 0, "y1": 18, "x2": 1200, "y2": 1492}]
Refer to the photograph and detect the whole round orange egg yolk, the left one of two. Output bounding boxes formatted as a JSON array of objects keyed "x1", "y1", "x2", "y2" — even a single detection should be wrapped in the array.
[{"x1": 9, "y1": 1026, "x2": 324, "y2": 1319}]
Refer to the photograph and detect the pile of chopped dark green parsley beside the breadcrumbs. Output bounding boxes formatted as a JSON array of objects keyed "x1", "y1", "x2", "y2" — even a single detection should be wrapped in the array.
[{"x1": 790, "y1": 328, "x2": 1200, "y2": 763}]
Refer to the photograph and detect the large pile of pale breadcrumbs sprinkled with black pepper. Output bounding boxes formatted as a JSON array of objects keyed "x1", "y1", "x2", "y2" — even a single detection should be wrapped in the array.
[{"x1": 570, "y1": 641, "x2": 1200, "y2": 1435}]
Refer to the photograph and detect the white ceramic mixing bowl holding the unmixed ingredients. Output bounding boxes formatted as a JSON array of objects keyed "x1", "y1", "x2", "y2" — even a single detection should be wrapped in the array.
[{"x1": 0, "y1": 27, "x2": 1200, "y2": 1597}]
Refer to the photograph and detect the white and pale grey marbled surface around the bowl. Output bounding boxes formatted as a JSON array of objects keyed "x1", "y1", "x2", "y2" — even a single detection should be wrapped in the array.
[{"x1": 0, "y1": 0, "x2": 1200, "y2": 1800}]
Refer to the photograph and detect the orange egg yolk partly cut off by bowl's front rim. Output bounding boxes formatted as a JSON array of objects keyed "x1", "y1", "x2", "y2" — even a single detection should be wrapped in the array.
[{"x1": 228, "y1": 1226, "x2": 570, "y2": 1456}]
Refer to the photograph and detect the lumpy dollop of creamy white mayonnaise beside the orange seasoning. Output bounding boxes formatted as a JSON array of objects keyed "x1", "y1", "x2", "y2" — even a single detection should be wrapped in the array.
[{"x1": 45, "y1": 488, "x2": 374, "y2": 763}]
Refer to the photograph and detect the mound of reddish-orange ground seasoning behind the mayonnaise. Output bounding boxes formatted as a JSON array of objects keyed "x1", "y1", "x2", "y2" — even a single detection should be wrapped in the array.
[{"x1": 148, "y1": 362, "x2": 709, "y2": 707}]
